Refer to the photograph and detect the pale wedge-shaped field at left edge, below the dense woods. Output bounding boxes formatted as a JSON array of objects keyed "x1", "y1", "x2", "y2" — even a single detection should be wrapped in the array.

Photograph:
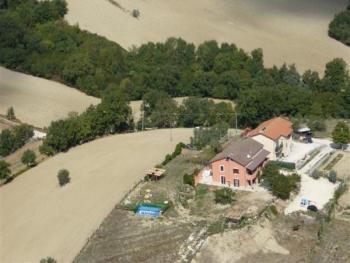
[{"x1": 0, "y1": 67, "x2": 99, "y2": 128}]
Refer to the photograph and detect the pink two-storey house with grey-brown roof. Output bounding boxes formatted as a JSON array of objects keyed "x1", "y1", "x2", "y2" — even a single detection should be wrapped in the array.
[{"x1": 195, "y1": 138, "x2": 270, "y2": 188}]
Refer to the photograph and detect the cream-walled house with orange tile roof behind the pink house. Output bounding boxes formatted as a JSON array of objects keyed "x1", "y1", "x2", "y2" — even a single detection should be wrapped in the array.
[{"x1": 247, "y1": 117, "x2": 293, "y2": 160}]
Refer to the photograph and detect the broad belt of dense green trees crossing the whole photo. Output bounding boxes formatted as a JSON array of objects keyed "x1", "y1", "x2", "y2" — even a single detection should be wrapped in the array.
[{"x1": 0, "y1": 0, "x2": 350, "y2": 154}]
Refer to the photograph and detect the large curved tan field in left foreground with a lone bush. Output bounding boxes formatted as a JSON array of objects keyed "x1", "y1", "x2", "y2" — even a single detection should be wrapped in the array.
[{"x1": 0, "y1": 129, "x2": 192, "y2": 262}]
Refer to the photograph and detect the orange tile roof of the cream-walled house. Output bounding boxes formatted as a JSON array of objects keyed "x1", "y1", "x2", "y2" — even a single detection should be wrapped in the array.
[{"x1": 247, "y1": 117, "x2": 293, "y2": 141}]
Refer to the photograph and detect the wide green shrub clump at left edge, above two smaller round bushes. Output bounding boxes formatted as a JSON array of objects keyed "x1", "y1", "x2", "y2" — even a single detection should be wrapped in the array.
[{"x1": 0, "y1": 124, "x2": 34, "y2": 157}]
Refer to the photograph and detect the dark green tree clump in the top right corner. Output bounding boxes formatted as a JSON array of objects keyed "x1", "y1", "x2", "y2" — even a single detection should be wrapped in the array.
[{"x1": 328, "y1": 1, "x2": 350, "y2": 46}]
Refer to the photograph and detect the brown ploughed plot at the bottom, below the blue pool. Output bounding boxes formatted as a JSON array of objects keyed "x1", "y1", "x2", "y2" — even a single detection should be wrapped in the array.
[{"x1": 74, "y1": 209, "x2": 194, "y2": 263}]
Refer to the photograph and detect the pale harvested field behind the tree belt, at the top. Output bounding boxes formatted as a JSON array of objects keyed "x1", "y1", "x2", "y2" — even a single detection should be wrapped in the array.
[{"x1": 66, "y1": 0, "x2": 350, "y2": 72}]
